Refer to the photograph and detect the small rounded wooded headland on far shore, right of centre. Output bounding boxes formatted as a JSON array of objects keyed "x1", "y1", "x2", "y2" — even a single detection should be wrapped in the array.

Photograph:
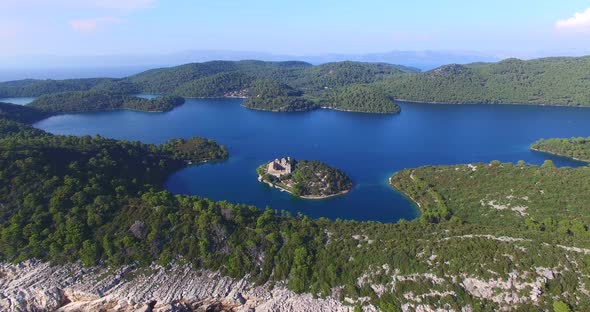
[{"x1": 322, "y1": 84, "x2": 401, "y2": 113}]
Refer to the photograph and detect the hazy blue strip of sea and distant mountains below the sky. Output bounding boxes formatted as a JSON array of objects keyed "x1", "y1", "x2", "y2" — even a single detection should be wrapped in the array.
[{"x1": 0, "y1": 50, "x2": 503, "y2": 81}]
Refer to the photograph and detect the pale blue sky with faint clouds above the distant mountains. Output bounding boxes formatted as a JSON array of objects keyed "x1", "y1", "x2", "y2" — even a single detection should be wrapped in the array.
[{"x1": 0, "y1": 0, "x2": 590, "y2": 56}]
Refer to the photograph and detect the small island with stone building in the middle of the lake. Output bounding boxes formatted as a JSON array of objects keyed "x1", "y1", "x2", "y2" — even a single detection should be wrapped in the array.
[{"x1": 256, "y1": 157, "x2": 352, "y2": 199}]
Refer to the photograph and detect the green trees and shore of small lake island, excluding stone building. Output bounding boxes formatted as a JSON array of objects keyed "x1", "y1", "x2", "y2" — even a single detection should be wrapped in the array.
[{"x1": 256, "y1": 159, "x2": 352, "y2": 197}]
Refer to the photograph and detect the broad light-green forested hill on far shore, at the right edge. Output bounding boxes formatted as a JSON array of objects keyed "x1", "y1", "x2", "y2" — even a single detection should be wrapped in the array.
[{"x1": 379, "y1": 57, "x2": 590, "y2": 106}]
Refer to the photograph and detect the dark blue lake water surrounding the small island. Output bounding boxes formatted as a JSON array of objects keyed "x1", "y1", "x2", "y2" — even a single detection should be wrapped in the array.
[{"x1": 35, "y1": 99, "x2": 590, "y2": 222}]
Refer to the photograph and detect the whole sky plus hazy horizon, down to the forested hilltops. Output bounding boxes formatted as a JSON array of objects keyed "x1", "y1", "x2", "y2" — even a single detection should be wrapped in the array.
[{"x1": 0, "y1": 0, "x2": 590, "y2": 81}]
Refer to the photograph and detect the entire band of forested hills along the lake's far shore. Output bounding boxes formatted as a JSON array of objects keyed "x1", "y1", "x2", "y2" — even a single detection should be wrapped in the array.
[{"x1": 0, "y1": 57, "x2": 590, "y2": 113}]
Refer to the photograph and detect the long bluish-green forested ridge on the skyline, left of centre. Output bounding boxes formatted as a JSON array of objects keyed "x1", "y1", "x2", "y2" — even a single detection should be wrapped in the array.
[{"x1": 128, "y1": 61, "x2": 412, "y2": 95}]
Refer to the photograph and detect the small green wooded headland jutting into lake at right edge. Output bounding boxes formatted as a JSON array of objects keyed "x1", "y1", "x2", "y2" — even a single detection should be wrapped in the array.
[{"x1": 531, "y1": 138, "x2": 590, "y2": 162}]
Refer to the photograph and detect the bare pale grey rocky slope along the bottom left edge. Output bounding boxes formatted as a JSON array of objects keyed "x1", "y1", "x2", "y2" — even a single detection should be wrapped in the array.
[{"x1": 0, "y1": 261, "x2": 360, "y2": 312}]
